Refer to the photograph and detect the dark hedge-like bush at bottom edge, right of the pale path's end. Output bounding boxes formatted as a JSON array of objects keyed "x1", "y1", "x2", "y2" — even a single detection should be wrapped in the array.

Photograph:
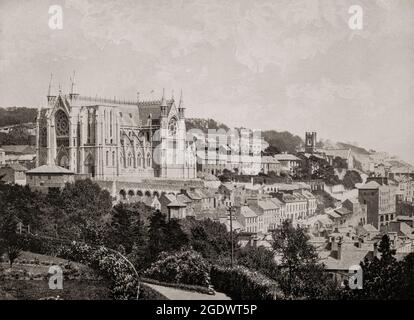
[{"x1": 210, "y1": 265, "x2": 285, "y2": 300}]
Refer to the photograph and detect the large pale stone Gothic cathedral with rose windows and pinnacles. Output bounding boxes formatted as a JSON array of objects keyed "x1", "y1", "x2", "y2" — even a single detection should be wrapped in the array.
[{"x1": 36, "y1": 86, "x2": 196, "y2": 181}]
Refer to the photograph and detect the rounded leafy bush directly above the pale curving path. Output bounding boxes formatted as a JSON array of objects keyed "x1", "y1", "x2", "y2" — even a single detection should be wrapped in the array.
[{"x1": 144, "y1": 250, "x2": 210, "y2": 287}]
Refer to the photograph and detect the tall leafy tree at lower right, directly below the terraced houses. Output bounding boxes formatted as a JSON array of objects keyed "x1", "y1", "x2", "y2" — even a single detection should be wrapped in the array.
[{"x1": 272, "y1": 220, "x2": 335, "y2": 299}]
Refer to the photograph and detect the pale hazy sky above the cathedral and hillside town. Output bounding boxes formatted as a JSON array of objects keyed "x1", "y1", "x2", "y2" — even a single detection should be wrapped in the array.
[{"x1": 0, "y1": 0, "x2": 414, "y2": 162}]
